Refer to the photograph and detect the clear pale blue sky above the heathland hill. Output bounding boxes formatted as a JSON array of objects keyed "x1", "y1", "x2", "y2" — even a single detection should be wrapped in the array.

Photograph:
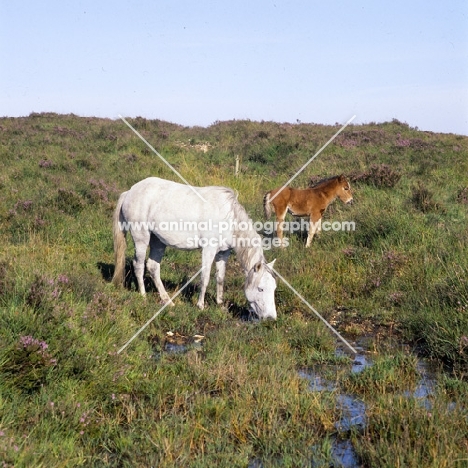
[{"x1": 0, "y1": 0, "x2": 468, "y2": 135}]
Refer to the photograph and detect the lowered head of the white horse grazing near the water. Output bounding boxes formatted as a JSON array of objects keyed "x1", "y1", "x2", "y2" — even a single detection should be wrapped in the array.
[{"x1": 245, "y1": 260, "x2": 276, "y2": 320}]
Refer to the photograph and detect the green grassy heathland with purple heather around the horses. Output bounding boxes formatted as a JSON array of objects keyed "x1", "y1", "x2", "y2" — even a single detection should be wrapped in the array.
[{"x1": 0, "y1": 114, "x2": 468, "y2": 467}]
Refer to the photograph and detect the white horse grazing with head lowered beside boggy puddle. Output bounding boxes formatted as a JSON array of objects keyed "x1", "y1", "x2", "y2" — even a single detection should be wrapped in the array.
[{"x1": 112, "y1": 177, "x2": 276, "y2": 319}]
